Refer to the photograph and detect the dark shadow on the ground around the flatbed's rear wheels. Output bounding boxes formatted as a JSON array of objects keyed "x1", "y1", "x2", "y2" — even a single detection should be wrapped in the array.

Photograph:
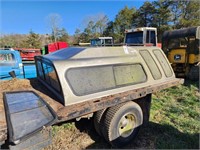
[{"x1": 75, "y1": 119, "x2": 199, "y2": 149}]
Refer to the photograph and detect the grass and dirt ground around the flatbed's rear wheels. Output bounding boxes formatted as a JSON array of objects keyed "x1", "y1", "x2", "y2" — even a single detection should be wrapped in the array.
[{"x1": 47, "y1": 81, "x2": 200, "y2": 149}]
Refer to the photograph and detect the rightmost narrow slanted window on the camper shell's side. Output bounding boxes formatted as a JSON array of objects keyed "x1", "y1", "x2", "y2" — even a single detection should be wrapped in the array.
[{"x1": 153, "y1": 50, "x2": 172, "y2": 77}]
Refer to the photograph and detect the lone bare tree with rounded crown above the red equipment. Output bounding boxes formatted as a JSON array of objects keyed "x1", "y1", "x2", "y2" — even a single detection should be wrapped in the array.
[{"x1": 46, "y1": 13, "x2": 62, "y2": 42}]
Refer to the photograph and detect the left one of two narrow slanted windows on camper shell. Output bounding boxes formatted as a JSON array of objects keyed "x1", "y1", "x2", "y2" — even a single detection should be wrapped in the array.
[{"x1": 140, "y1": 50, "x2": 161, "y2": 80}]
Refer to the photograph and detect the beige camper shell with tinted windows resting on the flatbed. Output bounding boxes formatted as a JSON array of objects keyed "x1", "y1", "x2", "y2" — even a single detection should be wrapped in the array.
[{"x1": 36, "y1": 46, "x2": 175, "y2": 106}]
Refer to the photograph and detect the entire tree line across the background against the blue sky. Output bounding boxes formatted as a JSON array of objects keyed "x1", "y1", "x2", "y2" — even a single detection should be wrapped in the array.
[{"x1": 0, "y1": 0, "x2": 200, "y2": 48}]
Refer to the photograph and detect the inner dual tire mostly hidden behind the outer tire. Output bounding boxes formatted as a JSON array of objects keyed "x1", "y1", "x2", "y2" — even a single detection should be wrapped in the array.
[{"x1": 94, "y1": 109, "x2": 106, "y2": 136}]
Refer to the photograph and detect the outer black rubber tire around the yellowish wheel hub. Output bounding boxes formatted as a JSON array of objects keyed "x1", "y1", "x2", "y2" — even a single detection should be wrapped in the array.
[{"x1": 101, "y1": 101, "x2": 143, "y2": 148}]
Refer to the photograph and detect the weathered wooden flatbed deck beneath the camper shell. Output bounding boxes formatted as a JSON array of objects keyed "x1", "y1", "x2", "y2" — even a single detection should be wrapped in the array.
[{"x1": 0, "y1": 79, "x2": 184, "y2": 148}]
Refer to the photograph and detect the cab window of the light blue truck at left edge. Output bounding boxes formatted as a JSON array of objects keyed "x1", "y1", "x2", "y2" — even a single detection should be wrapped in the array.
[{"x1": 0, "y1": 54, "x2": 15, "y2": 66}]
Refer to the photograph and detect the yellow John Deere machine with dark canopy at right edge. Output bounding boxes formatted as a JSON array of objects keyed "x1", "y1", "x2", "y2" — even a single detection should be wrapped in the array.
[{"x1": 162, "y1": 26, "x2": 200, "y2": 80}]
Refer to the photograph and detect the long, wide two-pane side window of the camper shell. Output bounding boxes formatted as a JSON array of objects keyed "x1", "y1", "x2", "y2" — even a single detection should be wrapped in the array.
[{"x1": 65, "y1": 64, "x2": 146, "y2": 96}]
